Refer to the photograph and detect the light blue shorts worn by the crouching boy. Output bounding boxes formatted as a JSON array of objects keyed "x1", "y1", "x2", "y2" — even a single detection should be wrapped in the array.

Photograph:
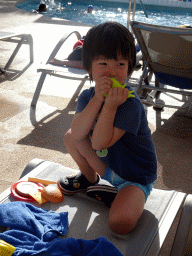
[{"x1": 103, "y1": 167, "x2": 154, "y2": 201}]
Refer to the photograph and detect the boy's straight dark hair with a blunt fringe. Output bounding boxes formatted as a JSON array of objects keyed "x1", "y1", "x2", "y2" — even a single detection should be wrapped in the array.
[{"x1": 82, "y1": 22, "x2": 136, "y2": 80}]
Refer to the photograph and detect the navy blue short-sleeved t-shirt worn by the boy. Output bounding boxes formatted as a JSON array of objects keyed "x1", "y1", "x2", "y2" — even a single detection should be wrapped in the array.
[{"x1": 76, "y1": 86, "x2": 157, "y2": 185}]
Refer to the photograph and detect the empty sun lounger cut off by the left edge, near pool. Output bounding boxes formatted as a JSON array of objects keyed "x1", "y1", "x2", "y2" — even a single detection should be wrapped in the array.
[{"x1": 0, "y1": 32, "x2": 33, "y2": 73}]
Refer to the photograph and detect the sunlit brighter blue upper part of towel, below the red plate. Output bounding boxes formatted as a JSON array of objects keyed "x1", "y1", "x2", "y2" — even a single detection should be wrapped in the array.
[{"x1": 0, "y1": 202, "x2": 68, "y2": 242}]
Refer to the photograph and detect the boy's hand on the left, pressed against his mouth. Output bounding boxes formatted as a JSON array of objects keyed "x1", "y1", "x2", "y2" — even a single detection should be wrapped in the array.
[{"x1": 95, "y1": 76, "x2": 113, "y2": 102}]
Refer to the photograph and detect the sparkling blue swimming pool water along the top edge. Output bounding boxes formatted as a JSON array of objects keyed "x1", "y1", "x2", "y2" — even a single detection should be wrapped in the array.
[{"x1": 17, "y1": 0, "x2": 192, "y2": 27}]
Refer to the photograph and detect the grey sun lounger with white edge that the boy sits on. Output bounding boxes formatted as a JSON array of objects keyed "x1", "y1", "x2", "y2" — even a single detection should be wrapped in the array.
[{"x1": 0, "y1": 159, "x2": 186, "y2": 256}]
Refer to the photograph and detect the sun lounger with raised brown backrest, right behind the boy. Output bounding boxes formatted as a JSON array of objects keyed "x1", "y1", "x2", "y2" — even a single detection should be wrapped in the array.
[{"x1": 131, "y1": 21, "x2": 192, "y2": 108}]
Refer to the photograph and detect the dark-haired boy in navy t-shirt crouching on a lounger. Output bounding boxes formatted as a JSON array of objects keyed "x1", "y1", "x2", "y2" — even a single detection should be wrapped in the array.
[{"x1": 58, "y1": 22, "x2": 157, "y2": 234}]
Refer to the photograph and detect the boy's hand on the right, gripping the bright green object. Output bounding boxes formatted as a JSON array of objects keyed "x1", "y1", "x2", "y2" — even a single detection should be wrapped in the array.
[{"x1": 105, "y1": 87, "x2": 129, "y2": 108}]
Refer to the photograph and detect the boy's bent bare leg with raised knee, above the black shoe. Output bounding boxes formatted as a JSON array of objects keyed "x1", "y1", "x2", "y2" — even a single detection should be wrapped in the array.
[{"x1": 64, "y1": 130, "x2": 107, "y2": 183}]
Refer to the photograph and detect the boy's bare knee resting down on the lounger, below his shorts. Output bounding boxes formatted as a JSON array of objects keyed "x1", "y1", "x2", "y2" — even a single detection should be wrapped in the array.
[{"x1": 109, "y1": 186, "x2": 145, "y2": 234}]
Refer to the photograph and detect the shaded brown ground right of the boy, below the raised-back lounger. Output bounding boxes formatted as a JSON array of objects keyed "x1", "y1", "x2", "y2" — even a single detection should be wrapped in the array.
[{"x1": 153, "y1": 110, "x2": 192, "y2": 193}]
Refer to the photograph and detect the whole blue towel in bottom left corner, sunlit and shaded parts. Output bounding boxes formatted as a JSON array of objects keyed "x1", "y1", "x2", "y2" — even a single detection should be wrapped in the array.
[{"x1": 0, "y1": 202, "x2": 122, "y2": 256}]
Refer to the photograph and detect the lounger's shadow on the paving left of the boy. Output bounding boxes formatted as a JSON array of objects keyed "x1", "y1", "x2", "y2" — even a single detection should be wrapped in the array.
[{"x1": 17, "y1": 76, "x2": 83, "y2": 153}]
